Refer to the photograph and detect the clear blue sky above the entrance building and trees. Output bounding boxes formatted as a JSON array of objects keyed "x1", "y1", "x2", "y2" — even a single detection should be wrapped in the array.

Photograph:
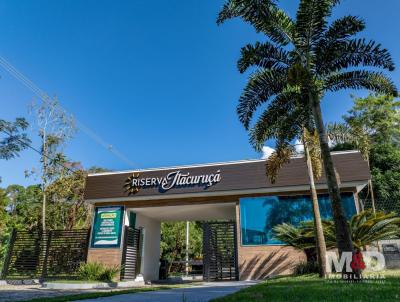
[{"x1": 0, "y1": 0, "x2": 400, "y2": 186}]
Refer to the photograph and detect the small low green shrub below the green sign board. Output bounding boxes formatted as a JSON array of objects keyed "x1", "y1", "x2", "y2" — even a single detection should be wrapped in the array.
[{"x1": 78, "y1": 262, "x2": 119, "y2": 282}]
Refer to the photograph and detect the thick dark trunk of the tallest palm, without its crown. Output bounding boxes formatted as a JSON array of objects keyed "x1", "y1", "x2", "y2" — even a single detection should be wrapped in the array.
[{"x1": 309, "y1": 93, "x2": 354, "y2": 255}]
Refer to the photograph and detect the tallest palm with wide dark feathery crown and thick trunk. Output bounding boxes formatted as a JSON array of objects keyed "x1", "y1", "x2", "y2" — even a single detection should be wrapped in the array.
[{"x1": 217, "y1": 0, "x2": 397, "y2": 260}]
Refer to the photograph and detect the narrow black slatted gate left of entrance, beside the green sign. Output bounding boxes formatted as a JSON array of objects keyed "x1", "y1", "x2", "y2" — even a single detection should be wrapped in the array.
[{"x1": 121, "y1": 226, "x2": 141, "y2": 280}]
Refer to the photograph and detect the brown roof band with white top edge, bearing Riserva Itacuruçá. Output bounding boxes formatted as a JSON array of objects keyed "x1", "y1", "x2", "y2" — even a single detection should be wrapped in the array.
[{"x1": 85, "y1": 151, "x2": 370, "y2": 202}]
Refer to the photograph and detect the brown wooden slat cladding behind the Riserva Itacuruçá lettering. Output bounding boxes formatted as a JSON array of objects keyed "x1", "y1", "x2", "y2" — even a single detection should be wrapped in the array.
[{"x1": 85, "y1": 152, "x2": 370, "y2": 199}]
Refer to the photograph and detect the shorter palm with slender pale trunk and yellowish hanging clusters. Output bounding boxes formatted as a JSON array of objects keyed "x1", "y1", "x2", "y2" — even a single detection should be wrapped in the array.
[{"x1": 242, "y1": 64, "x2": 327, "y2": 277}]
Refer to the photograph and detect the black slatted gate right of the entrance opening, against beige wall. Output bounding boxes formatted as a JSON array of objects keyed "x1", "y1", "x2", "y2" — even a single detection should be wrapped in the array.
[{"x1": 203, "y1": 221, "x2": 239, "y2": 281}]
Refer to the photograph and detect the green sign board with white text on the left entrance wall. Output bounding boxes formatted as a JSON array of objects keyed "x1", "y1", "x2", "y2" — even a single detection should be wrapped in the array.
[{"x1": 91, "y1": 207, "x2": 124, "y2": 248}]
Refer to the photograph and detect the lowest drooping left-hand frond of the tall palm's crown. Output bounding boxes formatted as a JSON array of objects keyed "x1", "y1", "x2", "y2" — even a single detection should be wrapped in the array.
[{"x1": 237, "y1": 69, "x2": 287, "y2": 129}]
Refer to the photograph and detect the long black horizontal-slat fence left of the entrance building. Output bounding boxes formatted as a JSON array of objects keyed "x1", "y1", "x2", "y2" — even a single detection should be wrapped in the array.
[{"x1": 1, "y1": 229, "x2": 90, "y2": 279}]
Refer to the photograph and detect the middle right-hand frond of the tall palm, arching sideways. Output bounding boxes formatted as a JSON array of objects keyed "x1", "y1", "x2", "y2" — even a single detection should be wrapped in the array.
[{"x1": 318, "y1": 39, "x2": 395, "y2": 73}]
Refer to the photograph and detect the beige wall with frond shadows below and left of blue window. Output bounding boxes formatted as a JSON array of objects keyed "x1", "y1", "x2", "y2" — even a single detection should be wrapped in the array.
[{"x1": 236, "y1": 201, "x2": 306, "y2": 280}]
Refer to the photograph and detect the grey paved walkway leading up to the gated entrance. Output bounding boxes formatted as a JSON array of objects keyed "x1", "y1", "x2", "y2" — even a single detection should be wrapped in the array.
[{"x1": 81, "y1": 281, "x2": 257, "y2": 302}]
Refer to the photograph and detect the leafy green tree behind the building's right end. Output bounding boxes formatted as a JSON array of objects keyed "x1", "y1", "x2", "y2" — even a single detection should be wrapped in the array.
[{"x1": 328, "y1": 95, "x2": 400, "y2": 213}]
